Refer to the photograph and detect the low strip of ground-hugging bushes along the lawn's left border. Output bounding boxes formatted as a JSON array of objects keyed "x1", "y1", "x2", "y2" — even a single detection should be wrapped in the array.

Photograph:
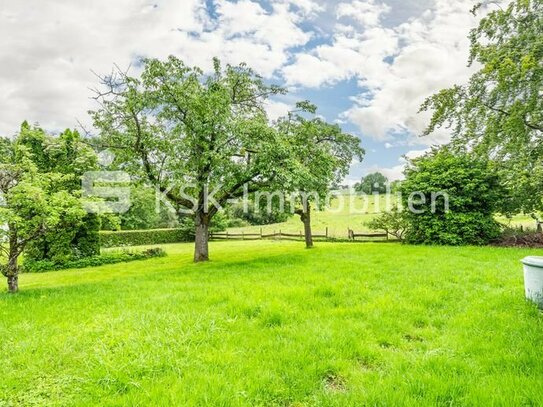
[{"x1": 21, "y1": 248, "x2": 166, "y2": 273}]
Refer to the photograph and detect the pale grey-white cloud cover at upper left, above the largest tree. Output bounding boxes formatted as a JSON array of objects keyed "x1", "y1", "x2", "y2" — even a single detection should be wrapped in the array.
[{"x1": 0, "y1": 0, "x2": 314, "y2": 135}]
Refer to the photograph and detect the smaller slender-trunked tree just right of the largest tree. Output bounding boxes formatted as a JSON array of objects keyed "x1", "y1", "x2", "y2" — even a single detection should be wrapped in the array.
[{"x1": 277, "y1": 102, "x2": 364, "y2": 248}]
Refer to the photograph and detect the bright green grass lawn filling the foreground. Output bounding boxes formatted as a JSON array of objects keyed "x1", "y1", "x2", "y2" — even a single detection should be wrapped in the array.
[{"x1": 0, "y1": 241, "x2": 543, "y2": 406}]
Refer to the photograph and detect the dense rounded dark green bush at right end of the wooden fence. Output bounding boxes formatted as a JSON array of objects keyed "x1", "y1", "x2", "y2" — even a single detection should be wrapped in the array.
[{"x1": 401, "y1": 148, "x2": 505, "y2": 245}]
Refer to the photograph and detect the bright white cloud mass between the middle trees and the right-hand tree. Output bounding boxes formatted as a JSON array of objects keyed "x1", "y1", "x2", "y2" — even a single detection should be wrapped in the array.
[{"x1": 283, "y1": 0, "x2": 476, "y2": 144}]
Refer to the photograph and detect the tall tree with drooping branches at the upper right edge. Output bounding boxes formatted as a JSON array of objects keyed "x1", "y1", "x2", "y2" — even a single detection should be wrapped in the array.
[{"x1": 422, "y1": 0, "x2": 543, "y2": 215}]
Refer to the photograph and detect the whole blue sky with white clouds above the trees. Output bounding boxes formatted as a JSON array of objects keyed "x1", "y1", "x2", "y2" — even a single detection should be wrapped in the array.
[{"x1": 0, "y1": 0, "x2": 484, "y2": 183}]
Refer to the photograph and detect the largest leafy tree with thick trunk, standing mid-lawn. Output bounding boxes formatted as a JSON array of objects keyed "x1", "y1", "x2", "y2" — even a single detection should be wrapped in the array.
[{"x1": 91, "y1": 56, "x2": 292, "y2": 262}]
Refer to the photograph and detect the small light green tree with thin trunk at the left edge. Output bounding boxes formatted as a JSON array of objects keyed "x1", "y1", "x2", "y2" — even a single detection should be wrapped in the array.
[{"x1": 0, "y1": 140, "x2": 85, "y2": 293}]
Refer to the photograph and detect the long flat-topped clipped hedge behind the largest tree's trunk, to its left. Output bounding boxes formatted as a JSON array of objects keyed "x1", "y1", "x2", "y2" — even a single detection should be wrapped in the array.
[{"x1": 100, "y1": 228, "x2": 194, "y2": 247}]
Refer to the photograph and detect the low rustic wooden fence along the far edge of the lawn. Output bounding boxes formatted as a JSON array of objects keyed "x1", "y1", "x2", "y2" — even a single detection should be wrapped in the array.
[{"x1": 209, "y1": 228, "x2": 389, "y2": 242}]
